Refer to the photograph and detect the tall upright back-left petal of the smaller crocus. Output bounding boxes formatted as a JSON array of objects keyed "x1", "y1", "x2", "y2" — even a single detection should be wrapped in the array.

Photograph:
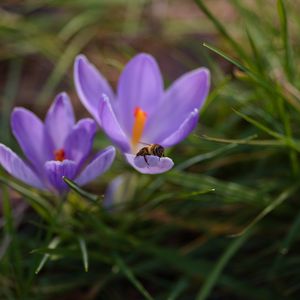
[{"x1": 11, "y1": 107, "x2": 53, "y2": 170}]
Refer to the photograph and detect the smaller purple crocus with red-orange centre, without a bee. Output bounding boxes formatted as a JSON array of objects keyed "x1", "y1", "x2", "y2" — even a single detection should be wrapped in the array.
[{"x1": 0, "y1": 93, "x2": 115, "y2": 193}]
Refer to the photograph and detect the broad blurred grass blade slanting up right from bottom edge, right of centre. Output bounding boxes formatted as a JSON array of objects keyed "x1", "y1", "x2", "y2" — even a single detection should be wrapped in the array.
[{"x1": 196, "y1": 232, "x2": 250, "y2": 300}]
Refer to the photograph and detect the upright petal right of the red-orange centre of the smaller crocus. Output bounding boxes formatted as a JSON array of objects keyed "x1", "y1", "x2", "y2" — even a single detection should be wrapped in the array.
[{"x1": 64, "y1": 118, "x2": 96, "y2": 165}]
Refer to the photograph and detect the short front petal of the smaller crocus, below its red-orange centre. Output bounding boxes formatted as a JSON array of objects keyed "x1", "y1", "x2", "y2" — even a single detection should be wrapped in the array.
[{"x1": 45, "y1": 159, "x2": 77, "y2": 192}]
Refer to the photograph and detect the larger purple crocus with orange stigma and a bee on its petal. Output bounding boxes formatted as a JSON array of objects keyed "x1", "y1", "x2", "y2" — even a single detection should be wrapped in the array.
[{"x1": 74, "y1": 53, "x2": 210, "y2": 174}]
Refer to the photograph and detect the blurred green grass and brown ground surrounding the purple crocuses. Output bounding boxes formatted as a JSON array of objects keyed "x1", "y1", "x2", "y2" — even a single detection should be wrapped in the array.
[{"x1": 0, "y1": 0, "x2": 300, "y2": 300}]
